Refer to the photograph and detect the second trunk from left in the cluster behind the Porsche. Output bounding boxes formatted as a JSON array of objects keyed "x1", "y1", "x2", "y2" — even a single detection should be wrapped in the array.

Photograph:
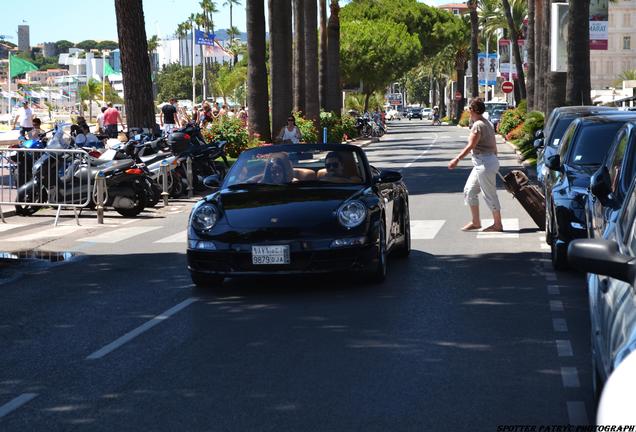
[{"x1": 269, "y1": 0, "x2": 293, "y2": 136}]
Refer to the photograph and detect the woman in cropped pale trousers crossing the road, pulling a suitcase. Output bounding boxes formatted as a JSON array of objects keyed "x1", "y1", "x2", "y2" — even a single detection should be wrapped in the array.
[{"x1": 448, "y1": 98, "x2": 503, "y2": 232}]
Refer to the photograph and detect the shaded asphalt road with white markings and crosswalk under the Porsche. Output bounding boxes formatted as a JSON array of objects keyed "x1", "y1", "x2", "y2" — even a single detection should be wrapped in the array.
[{"x1": 0, "y1": 120, "x2": 594, "y2": 432}]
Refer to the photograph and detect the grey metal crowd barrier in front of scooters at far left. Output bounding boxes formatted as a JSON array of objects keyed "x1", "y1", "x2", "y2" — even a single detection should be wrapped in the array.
[{"x1": 0, "y1": 148, "x2": 95, "y2": 225}]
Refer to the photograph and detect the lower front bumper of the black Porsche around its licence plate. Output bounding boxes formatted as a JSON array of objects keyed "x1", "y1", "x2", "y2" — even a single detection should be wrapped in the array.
[{"x1": 187, "y1": 241, "x2": 378, "y2": 277}]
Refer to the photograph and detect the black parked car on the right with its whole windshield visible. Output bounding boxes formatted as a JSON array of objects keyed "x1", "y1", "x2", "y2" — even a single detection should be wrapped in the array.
[{"x1": 544, "y1": 113, "x2": 636, "y2": 270}]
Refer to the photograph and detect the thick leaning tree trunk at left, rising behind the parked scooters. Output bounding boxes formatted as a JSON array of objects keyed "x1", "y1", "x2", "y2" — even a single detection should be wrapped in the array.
[{"x1": 115, "y1": 0, "x2": 156, "y2": 129}]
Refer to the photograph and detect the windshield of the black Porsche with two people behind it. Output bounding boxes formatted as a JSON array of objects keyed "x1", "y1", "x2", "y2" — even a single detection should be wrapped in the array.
[{"x1": 223, "y1": 144, "x2": 366, "y2": 187}]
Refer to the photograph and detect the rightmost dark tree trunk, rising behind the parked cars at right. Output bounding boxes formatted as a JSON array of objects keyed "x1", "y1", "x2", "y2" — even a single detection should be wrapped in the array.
[{"x1": 565, "y1": 0, "x2": 592, "y2": 105}]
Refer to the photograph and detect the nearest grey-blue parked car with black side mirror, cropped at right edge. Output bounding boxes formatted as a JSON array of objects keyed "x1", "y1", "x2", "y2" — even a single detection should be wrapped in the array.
[{"x1": 568, "y1": 175, "x2": 636, "y2": 405}]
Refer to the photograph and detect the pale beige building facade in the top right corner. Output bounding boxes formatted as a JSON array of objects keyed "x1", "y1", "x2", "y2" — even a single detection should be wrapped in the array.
[{"x1": 590, "y1": 0, "x2": 636, "y2": 89}]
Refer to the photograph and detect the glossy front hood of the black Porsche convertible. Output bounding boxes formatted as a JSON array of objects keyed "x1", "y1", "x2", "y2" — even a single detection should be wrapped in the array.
[{"x1": 218, "y1": 186, "x2": 365, "y2": 229}]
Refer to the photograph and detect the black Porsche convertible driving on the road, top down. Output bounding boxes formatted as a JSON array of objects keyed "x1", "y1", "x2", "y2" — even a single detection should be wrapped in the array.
[{"x1": 187, "y1": 144, "x2": 411, "y2": 287}]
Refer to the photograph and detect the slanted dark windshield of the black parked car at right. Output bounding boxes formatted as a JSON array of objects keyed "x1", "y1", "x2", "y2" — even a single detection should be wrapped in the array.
[{"x1": 569, "y1": 122, "x2": 623, "y2": 165}]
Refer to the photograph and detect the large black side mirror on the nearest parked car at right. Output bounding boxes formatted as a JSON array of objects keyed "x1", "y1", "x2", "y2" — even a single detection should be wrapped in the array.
[{"x1": 567, "y1": 239, "x2": 636, "y2": 285}]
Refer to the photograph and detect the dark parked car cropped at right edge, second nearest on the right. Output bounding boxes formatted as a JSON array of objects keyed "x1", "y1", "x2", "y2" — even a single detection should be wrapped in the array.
[{"x1": 585, "y1": 121, "x2": 636, "y2": 238}]
